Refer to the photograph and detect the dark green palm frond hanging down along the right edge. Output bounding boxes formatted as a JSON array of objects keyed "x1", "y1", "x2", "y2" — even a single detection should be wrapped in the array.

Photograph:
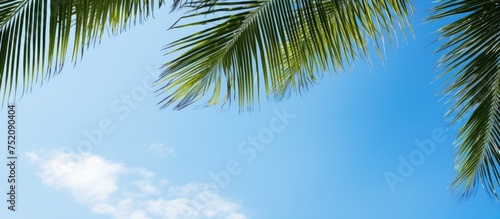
[{"x1": 431, "y1": 0, "x2": 500, "y2": 198}]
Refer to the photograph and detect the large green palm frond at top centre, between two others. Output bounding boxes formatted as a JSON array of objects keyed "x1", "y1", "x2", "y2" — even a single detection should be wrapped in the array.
[{"x1": 158, "y1": 0, "x2": 412, "y2": 109}]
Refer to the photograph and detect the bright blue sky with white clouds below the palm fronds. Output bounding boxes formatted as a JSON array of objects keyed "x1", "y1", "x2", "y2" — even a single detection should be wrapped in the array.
[{"x1": 0, "y1": 2, "x2": 500, "y2": 219}]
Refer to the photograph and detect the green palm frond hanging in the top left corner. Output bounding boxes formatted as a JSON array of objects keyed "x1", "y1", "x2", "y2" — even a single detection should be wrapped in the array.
[{"x1": 0, "y1": 0, "x2": 163, "y2": 102}]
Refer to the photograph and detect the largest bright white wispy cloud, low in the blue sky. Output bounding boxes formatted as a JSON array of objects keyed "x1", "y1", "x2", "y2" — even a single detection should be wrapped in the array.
[{"x1": 29, "y1": 152, "x2": 246, "y2": 219}]
